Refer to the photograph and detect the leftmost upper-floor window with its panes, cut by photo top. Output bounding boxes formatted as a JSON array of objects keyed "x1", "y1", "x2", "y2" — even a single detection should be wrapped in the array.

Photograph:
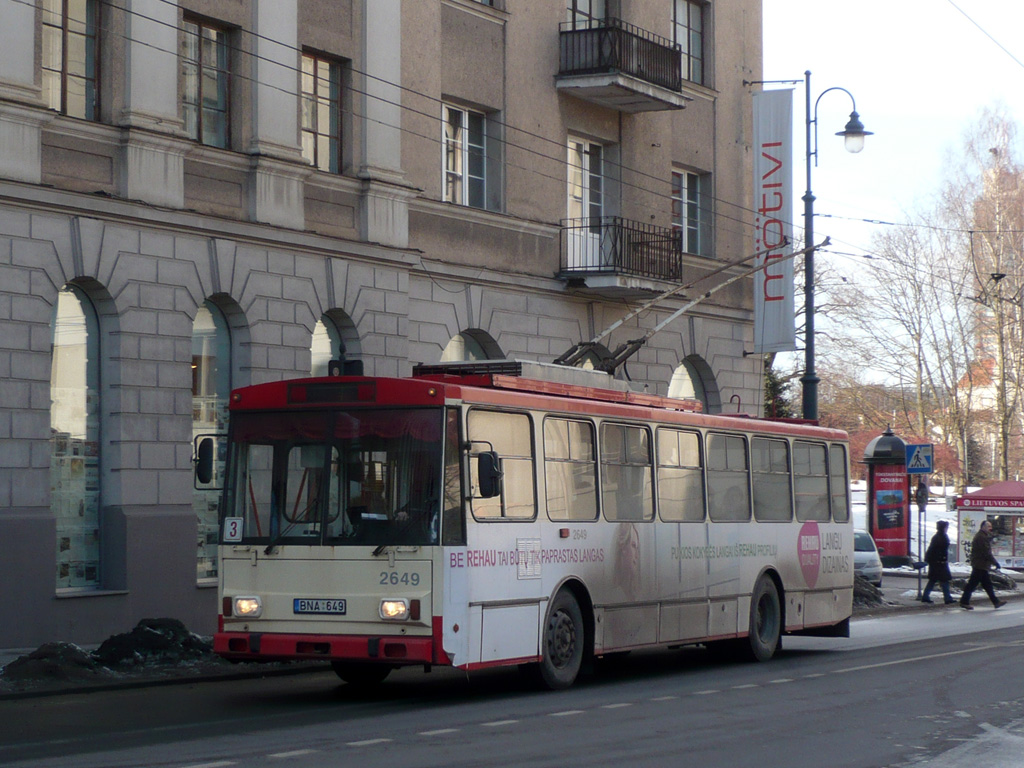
[{"x1": 42, "y1": 0, "x2": 99, "y2": 120}]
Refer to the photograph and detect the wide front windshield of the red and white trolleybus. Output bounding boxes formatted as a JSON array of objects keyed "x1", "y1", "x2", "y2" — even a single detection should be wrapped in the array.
[{"x1": 221, "y1": 409, "x2": 443, "y2": 550}]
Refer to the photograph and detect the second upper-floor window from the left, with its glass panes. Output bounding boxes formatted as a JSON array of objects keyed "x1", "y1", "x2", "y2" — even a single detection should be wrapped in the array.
[{"x1": 181, "y1": 19, "x2": 230, "y2": 148}]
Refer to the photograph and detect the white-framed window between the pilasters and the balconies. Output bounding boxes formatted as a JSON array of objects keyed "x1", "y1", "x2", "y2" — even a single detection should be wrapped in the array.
[{"x1": 442, "y1": 104, "x2": 487, "y2": 208}]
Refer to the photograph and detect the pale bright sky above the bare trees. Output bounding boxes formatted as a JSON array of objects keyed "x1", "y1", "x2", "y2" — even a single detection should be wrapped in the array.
[{"x1": 763, "y1": 0, "x2": 1024, "y2": 268}]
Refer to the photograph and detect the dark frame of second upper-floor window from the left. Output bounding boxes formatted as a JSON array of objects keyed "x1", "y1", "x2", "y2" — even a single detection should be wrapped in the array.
[{"x1": 180, "y1": 15, "x2": 233, "y2": 150}]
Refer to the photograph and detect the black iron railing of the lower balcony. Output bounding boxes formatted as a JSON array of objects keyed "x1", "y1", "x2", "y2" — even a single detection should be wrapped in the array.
[{"x1": 561, "y1": 216, "x2": 683, "y2": 281}]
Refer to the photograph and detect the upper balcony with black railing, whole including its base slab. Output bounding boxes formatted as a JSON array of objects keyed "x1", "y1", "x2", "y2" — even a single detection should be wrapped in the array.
[{"x1": 555, "y1": 18, "x2": 691, "y2": 113}]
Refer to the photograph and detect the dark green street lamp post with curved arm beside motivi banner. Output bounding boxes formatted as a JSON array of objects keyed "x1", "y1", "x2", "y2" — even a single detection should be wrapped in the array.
[{"x1": 800, "y1": 70, "x2": 871, "y2": 421}]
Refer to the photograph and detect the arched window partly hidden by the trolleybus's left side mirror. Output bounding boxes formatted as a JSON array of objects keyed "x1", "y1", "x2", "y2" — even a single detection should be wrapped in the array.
[{"x1": 191, "y1": 301, "x2": 231, "y2": 579}]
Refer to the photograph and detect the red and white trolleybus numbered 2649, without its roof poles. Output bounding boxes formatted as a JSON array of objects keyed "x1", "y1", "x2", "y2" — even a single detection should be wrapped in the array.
[{"x1": 209, "y1": 361, "x2": 853, "y2": 688}]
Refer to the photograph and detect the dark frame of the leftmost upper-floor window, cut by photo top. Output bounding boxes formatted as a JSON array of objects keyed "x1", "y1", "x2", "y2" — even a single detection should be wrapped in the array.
[{"x1": 40, "y1": 0, "x2": 103, "y2": 122}]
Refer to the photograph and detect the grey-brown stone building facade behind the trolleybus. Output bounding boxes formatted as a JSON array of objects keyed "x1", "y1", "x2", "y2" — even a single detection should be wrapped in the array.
[{"x1": 0, "y1": 0, "x2": 762, "y2": 647}]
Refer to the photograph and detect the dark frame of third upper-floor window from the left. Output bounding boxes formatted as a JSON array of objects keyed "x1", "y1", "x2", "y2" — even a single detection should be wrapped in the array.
[{"x1": 299, "y1": 50, "x2": 345, "y2": 174}]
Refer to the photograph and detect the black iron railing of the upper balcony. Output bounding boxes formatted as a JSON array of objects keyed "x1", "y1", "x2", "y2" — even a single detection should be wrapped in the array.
[{"x1": 558, "y1": 18, "x2": 683, "y2": 91}]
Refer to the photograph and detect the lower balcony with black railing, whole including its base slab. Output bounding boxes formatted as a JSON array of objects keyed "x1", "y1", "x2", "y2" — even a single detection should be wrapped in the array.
[{"x1": 558, "y1": 216, "x2": 683, "y2": 298}]
